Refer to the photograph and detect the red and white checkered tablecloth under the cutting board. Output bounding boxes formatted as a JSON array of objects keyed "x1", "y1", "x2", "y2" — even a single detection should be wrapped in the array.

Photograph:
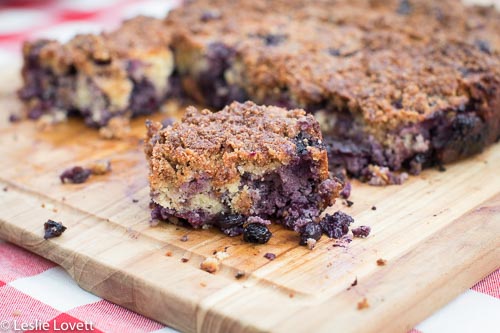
[{"x1": 0, "y1": 0, "x2": 500, "y2": 333}]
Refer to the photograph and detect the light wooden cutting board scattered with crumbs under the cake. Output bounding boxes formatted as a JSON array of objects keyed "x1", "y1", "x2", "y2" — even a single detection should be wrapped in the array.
[{"x1": 0, "y1": 63, "x2": 500, "y2": 332}]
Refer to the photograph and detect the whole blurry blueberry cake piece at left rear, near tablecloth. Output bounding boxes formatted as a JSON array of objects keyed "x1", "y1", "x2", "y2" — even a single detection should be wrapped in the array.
[{"x1": 19, "y1": 16, "x2": 174, "y2": 127}]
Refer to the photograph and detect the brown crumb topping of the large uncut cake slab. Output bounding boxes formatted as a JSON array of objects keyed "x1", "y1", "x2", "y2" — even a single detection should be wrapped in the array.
[{"x1": 166, "y1": 0, "x2": 500, "y2": 132}]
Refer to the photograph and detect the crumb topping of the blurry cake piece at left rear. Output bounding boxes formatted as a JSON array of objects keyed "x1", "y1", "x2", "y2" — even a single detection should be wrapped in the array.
[{"x1": 23, "y1": 16, "x2": 170, "y2": 76}]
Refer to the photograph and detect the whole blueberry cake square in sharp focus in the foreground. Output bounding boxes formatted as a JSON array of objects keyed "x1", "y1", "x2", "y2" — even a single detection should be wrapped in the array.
[{"x1": 145, "y1": 102, "x2": 342, "y2": 236}]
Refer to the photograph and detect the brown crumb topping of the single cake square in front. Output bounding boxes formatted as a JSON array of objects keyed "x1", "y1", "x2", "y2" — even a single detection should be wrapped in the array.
[{"x1": 146, "y1": 102, "x2": 328, "y2": 186}]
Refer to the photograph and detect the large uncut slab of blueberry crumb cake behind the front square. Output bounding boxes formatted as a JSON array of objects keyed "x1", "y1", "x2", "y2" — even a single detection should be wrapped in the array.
[{"x1": 166, "y1": 0, "x2": 500, "y2": 185}]
